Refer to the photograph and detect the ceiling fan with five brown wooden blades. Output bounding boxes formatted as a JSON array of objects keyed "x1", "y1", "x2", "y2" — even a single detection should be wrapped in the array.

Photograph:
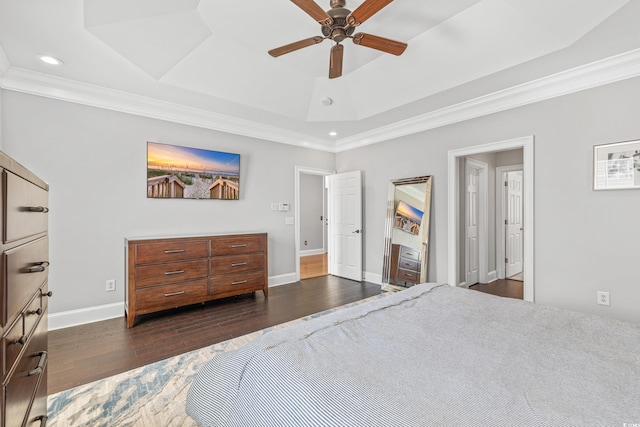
[{"x1": 269, "y1": 0, "x2": 407, "y2": 79}]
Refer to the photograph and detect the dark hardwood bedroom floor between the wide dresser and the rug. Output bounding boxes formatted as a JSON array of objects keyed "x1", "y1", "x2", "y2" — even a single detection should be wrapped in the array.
[{"x1": 47, "y1": 276, "x2": 380, "y2": 394}]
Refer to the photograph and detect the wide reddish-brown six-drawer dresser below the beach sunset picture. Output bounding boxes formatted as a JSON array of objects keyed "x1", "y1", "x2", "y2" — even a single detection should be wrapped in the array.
[{"x1": 125, "y1": 233, "x2": 269, "y2": 328}]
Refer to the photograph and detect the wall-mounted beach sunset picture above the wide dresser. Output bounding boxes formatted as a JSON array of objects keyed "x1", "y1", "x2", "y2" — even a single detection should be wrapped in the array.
[{"x1": 147, "y1": 141, "x2": 240, "y2": 200}]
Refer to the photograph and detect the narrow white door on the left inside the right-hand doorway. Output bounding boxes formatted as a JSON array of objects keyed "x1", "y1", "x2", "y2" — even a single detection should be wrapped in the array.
[{"x1": 465, "y1": 164, "x2": 480, "y2": 286}]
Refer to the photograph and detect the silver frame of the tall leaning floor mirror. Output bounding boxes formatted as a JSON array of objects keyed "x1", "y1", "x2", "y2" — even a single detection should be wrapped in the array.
[{"x1": 382, "y1": 175, "x2": 433, "y2": 286}]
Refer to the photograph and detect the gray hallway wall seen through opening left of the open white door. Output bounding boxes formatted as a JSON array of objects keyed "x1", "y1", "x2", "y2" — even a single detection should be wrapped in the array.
[{"x1": 300, "y1": 173, "x2": 325, "y2": 255}]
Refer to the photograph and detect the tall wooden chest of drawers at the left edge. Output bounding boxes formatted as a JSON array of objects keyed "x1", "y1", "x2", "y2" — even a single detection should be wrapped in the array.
[{"x1": 0, "y1": 153, "x2": 51, "y2": 427}]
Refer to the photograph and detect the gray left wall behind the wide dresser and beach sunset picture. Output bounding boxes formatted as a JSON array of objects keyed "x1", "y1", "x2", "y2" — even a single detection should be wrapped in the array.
[{"x1": 2, "y1": 91, "x2": 335, "y2": 314}]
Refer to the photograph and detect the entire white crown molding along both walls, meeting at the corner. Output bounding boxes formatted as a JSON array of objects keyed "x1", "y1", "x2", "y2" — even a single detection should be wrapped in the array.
[{"x1": 0, "y1": 49, "x2": 640, "y2": 153}]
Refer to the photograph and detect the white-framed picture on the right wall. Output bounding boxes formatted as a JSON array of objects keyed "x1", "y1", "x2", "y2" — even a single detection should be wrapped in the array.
[{"x1": 593, "y1": 140, "x2": 640, "y2": 190}]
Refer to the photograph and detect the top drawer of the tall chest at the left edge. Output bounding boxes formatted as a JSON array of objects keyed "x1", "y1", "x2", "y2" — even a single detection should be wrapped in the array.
[{"x1": 2, "y1": 171, "x2": 49, "y2": 243}]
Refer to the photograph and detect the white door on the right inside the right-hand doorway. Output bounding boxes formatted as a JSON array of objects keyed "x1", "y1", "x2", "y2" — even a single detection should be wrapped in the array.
[{"x1": 505, "y1": 171, "x2": 523, "y2": 277}]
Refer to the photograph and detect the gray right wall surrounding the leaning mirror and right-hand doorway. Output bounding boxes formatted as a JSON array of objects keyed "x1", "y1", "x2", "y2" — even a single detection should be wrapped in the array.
[{"x1": 336, "y1": 78, "x2": 640, "y2": 321}]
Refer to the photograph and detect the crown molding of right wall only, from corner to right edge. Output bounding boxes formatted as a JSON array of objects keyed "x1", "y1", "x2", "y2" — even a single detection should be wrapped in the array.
[{"x1": 335, "y1": 49, "x2": 640, "y2": 153}]
